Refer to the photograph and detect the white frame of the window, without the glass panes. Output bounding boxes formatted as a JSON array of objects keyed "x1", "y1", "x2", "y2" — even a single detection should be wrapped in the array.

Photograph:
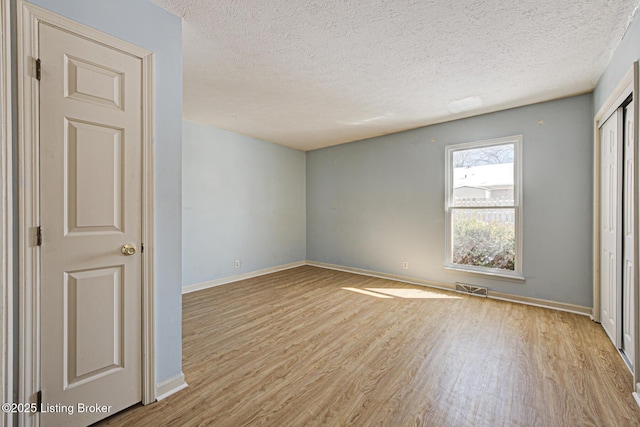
[{"x1": 444, "y1": 135, "x2": 524, "y2": 281}]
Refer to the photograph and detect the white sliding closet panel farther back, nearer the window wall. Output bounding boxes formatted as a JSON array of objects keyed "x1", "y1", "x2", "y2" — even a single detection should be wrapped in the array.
[{"x1": 600, "y1": 111, "x2": 622, "y2": 346}]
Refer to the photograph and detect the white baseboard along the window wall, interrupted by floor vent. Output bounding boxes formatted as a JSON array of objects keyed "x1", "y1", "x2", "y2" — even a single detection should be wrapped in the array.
[{"x1": 307, "y1": 261, "x2": 592, "y2": 316}]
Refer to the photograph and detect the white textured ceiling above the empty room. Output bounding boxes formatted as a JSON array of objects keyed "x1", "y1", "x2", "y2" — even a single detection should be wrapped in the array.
[{"x1": 153, "y1": 0, "x2": 638, "y2": 150}]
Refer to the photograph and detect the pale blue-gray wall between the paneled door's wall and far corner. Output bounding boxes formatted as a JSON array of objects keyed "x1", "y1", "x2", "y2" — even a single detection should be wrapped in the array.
[{"x1": 182, "y1": 122, "x2": 306, "y2": 285}]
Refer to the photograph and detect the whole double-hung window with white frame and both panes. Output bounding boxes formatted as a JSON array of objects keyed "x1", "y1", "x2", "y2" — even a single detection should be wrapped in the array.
[{"x1": 445, "y1": 135, "x2": 522, "y2": 278}]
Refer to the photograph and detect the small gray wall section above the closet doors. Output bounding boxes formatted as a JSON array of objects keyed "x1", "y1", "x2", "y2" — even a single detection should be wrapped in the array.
[{"x1": 593, "y1": 13, "x2": 640, "y2": 112}]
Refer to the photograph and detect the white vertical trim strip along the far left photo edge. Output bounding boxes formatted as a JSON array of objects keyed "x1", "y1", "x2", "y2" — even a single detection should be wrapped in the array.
[{"x1": 0, "y1": 0, "x2": 14, "y2": 426}]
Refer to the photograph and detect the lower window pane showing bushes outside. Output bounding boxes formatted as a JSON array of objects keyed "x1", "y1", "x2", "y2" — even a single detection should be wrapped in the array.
[{"x1": 451, "y1": 209, "x2": 516, "y2": 271}]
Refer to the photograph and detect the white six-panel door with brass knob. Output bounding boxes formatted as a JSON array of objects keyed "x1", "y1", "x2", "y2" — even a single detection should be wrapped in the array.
[{"x1": 39, "y1": 24, "x2": 142, "y2": 426}]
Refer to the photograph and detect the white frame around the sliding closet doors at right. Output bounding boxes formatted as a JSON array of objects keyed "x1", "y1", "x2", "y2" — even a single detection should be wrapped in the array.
[{"x1": 591, "y1": 61, "x2": 640, "y2": 405}]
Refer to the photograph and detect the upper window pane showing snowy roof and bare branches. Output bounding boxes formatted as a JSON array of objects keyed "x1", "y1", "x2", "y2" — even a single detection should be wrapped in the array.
[{"x1": 453, "y1": 144, "x2": 515, "y2": 207}]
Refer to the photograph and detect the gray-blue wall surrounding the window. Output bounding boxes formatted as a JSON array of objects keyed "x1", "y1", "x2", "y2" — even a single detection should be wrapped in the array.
[{"x1": 307, "y1": 94, "x2": 593, "y2": 307}]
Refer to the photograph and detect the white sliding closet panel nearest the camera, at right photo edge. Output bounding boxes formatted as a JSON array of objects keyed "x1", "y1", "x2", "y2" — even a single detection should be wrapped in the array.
[{"x1": 622, "y1": 103, "x2": 635, "y2": 368}]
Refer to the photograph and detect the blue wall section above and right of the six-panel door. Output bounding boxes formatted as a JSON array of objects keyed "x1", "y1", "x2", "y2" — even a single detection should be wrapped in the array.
[{"x1": 32, "y1": 0, "x2": 182, "y2": 383}]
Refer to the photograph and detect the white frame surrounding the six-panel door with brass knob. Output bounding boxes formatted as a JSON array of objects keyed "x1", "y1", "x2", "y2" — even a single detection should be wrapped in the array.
[{"x1": 17, "y1": 0, "x2": 156, "y2": 426}]
